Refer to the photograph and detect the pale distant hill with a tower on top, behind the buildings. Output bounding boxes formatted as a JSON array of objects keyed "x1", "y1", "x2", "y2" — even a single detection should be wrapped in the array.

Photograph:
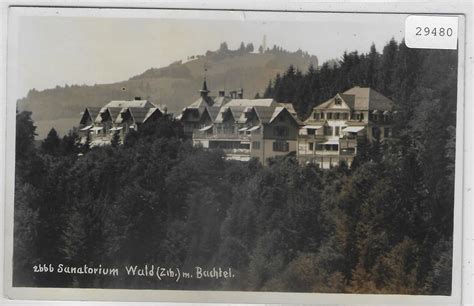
[{"x1": 18, "y1": 43, "x2": 318, "y2": 139}]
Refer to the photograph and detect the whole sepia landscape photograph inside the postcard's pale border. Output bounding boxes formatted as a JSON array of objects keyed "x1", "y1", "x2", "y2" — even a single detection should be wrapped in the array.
[{"x1": 1, "y1": 8, "x2": 462, "y2": 304}]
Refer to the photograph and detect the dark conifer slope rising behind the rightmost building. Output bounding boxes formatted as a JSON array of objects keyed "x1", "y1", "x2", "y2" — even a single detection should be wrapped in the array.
[{"x1": 264, "y1": 39, "x2": 457, "y2": 126}]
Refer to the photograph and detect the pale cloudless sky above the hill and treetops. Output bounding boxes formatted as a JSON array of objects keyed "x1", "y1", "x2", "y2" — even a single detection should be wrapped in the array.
[{"x1": 9, "y1": 9, "x2": 406, "y2": 98}]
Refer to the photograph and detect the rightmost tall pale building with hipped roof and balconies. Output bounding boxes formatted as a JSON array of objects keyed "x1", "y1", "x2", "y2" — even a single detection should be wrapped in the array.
[{"x1": 298, "y1": 86, "x2": 396, "y2": 168}]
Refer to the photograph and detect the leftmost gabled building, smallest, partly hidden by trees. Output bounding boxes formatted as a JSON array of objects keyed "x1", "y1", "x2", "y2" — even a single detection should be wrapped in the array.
[{"x1": 79, "y1": 97, "x2": 166, "y2": 146}]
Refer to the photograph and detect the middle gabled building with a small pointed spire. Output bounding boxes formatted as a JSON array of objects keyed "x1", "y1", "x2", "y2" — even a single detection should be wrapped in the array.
[{"x1": 178, "y1": 81, "x2": 301, "y2": 163}]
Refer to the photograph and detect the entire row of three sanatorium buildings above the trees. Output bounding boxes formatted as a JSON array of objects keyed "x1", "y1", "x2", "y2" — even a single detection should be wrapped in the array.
[{"x1": 79, "y1": 81, "x2": 396, "y2": 168}]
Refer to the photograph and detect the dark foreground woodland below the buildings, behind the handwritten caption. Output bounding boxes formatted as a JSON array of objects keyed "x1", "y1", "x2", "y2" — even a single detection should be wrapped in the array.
[{"x1": 13, "y1": 39, "x2": 456, "y2": 294}]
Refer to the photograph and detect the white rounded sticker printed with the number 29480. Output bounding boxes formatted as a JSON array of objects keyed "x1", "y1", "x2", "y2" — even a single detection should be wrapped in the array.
[{"x1": 405, "y1": 16, "x2": 458, "y2": 50}]
